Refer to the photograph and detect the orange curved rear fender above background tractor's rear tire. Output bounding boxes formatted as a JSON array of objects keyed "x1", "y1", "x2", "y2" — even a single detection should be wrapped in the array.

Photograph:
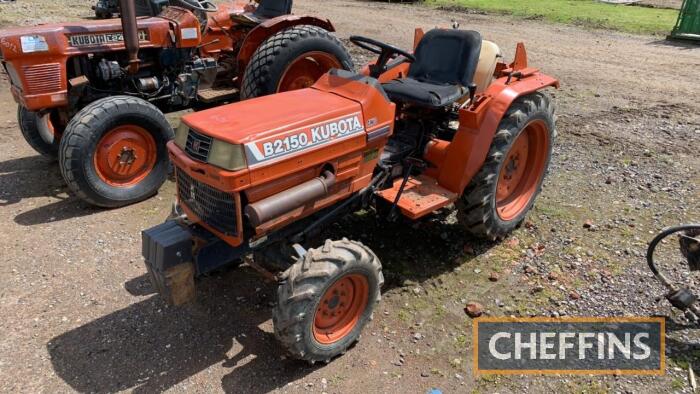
[{"x1": 238, "y1": 15, "x2": 335, "y2": 77}]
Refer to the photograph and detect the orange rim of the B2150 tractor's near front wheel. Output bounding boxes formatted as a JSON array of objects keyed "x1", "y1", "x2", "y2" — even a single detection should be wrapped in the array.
[{"x1": 313, "y1": 274, "x2": 369, "y2": 345}]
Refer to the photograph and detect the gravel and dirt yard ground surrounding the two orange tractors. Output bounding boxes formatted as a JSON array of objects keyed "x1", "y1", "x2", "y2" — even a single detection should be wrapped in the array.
[{"x1": 0, "y1": 0, "x2": 700, "y2": 393}]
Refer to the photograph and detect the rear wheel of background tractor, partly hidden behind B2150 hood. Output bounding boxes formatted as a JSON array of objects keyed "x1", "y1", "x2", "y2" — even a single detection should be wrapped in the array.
[{"x1": 241, "y1": 25, "x2": 355, "y2": 99}]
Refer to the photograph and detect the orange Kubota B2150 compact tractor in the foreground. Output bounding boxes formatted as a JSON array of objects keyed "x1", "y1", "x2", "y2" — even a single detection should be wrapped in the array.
[{"x1": 143, "y1": 29, "x2": 559, "y2": 363}]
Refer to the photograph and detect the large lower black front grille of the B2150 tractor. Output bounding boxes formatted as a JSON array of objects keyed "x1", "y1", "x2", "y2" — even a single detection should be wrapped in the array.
[{"x1": 176, "y1": 169, "x2": 238, "y2": 235}]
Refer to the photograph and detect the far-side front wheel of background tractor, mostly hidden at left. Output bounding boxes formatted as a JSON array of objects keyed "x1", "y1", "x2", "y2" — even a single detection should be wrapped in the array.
[{"x1": 17, "y1": 106, "x2": 59, "y2": 159}]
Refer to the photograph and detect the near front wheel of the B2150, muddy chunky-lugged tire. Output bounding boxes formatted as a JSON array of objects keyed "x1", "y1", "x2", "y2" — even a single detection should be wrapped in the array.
[{"x1": 272, "y1": 239, "x2": 384, "y2": 364}]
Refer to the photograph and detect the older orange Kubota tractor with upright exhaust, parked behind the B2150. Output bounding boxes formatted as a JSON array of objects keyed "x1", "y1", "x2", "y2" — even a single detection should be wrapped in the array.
[{"x1": 0, "y1": 0, "x2": 354, "y2": 207}]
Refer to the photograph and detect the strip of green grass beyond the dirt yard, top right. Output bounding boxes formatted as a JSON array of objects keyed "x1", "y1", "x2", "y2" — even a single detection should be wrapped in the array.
[{"x1": 426, "y1": 0, "x2": 678, "y2": 35}]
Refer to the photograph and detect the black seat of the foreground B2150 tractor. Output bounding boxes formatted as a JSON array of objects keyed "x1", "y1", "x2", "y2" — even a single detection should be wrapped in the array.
[{"x1": 383, "y1": 29, "x2": 481, "y2": 108}]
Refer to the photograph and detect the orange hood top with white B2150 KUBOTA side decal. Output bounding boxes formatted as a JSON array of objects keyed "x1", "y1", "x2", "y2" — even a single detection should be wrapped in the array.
[{"x1": 182, "y1": 88, "x2": 365, "y2": 166}]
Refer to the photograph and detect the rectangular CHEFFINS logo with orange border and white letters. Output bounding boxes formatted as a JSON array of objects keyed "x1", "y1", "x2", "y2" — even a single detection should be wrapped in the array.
[{"x1": 474, "y1": 317, "x2": 666, "y2": 375}]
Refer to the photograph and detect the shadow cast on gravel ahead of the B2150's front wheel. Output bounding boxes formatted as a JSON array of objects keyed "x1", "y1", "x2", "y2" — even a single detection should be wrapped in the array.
[{"x1": 47, "y1": 269, "x2": 320, "y2": 393}]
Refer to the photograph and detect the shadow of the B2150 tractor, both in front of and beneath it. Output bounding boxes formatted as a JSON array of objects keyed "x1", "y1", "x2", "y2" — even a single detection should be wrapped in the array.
[{"x1": 47, "y1": 206, "x2": 490, "y2": 392}]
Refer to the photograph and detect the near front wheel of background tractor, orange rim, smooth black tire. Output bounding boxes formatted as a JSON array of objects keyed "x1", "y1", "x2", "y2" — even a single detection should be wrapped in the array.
[{"x1": 59, "y1": 96, "x2": 174, "y2": 208}]
